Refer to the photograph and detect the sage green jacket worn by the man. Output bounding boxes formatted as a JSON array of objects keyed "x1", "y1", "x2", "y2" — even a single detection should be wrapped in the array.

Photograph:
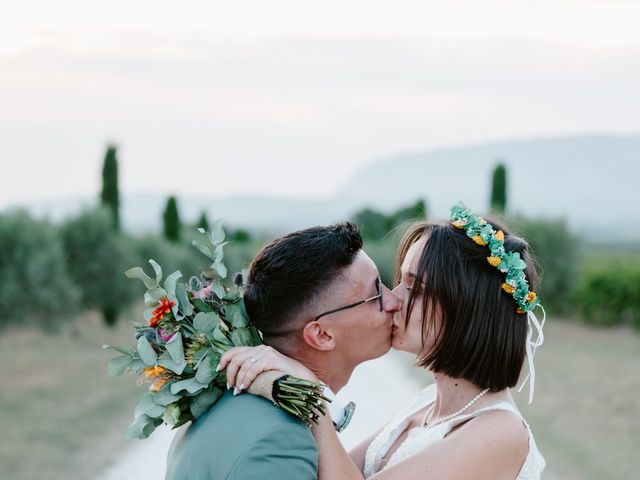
[{"x1": 166, "y1": 391, "x2": 318, "y2": 480}]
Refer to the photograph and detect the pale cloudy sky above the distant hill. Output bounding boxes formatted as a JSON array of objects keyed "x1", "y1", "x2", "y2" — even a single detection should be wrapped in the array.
[{"x1": 0, "y1": 0, "x2": 640, "y2": 208}]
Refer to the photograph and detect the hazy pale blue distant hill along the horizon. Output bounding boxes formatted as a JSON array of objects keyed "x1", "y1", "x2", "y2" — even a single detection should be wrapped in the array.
[{"x1": 20, "y1": 135, "x2": 640, "y2": 241}]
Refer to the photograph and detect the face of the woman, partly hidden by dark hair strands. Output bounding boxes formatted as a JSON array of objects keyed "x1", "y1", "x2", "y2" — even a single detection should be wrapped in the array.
[{"x1": 391, "y1": 235, "x2": 435, "y2": 355}]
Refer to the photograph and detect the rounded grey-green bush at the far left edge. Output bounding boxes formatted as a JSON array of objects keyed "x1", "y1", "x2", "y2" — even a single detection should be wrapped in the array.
[{"x1": 0, "y1": 210, "x2": 79, "y2": 329}]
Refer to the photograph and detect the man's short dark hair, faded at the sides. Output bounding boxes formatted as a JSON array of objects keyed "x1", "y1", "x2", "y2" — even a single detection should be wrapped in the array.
[{"x1": 244, "y1": 222, "x2": 362, "y2": 336}]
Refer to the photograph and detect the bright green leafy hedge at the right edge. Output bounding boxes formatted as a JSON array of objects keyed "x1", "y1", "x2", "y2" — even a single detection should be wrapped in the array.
[{"x1": 576, "y1": 262, "x2": 640, "y2": 328}]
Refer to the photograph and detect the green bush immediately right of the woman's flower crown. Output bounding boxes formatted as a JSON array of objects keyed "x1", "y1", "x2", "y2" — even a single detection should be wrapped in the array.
[{"x1": 514, "y1": 217, "x2": 580, "y2": 313}]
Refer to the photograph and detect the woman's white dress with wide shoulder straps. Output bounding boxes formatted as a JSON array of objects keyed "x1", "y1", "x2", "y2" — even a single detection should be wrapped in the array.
[{"x1": 364, "y1": 383, "x2": 545, "y2": 480}]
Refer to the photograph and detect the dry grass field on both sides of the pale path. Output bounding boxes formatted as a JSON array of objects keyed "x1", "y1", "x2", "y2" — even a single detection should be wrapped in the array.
[{"x1": 0, "y1": 315, "x2": 640, "y2": 480}]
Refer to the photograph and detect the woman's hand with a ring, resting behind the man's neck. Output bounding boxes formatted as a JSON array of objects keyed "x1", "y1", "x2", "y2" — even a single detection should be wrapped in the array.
[{"x1": 218, "y1": 345, "x2": 319, "y2": 394}]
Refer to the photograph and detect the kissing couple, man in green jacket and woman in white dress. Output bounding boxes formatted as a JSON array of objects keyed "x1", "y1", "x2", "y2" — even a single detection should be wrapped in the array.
[{"x1": 166, "y1": 204, "x2": 545, "y2": 480}]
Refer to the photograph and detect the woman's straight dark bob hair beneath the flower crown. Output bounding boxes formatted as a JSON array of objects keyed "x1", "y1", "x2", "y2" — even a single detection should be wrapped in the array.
[{"x1": 395, "y1": 217, "x2": 538, "y2": 392}]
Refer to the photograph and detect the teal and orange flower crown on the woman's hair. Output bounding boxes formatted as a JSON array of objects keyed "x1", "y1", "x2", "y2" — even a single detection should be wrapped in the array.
[{"x1": 450, "y1": 202, "x2": 540, "y2": 313}]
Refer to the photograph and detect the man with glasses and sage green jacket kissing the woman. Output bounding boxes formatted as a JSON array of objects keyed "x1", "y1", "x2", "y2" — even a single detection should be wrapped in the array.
[{"x1": 166, "y1": 223, "x2": 400, "y2": 480}]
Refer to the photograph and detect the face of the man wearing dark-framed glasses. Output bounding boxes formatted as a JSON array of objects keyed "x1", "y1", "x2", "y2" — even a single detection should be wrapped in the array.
[{"x1": 319, "y1": 250, "x2": 400, "y2": 365}]
